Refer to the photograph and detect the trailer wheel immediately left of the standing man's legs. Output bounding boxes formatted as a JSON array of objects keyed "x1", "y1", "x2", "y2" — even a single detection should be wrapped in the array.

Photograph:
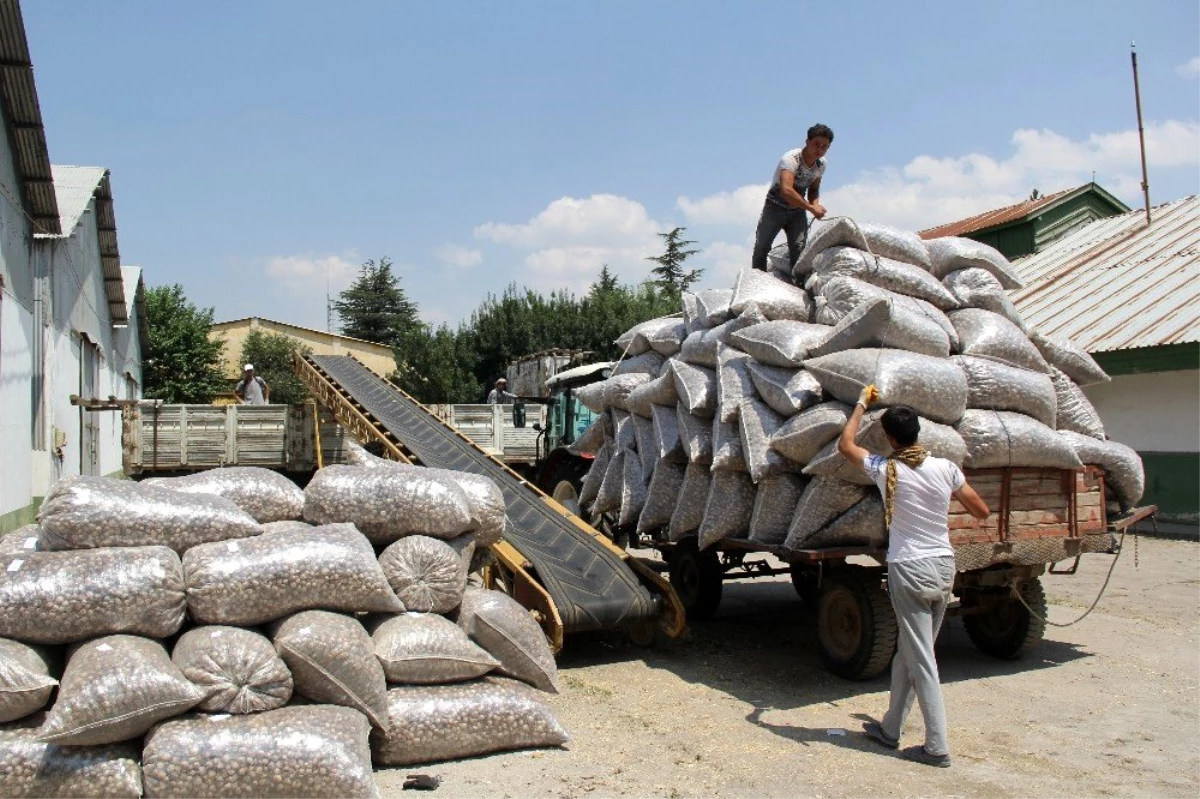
[{"x1": 817, "y1": 566, "x2": 896, "y2": 680}]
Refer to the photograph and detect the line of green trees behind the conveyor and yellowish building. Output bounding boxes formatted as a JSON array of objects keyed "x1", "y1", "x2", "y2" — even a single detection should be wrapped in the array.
[{"x1": 143, "y1": 228, "x2": 702, "y2": 404}]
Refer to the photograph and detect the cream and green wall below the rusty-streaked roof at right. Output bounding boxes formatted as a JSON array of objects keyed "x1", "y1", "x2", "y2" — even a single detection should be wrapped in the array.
[{"x1": 1085, "y1": 370, "x2": 1200, "y2": 524}]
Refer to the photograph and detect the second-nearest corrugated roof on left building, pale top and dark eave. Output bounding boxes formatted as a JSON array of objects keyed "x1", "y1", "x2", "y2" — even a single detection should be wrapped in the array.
[{"x1": 35, "y1": 164, "x2": 130, "y2": 324}]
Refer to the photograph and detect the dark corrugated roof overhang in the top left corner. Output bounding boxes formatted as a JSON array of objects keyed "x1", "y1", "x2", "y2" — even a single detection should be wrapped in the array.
[{"x1": 0, "y1": 0, "x2": 61, "y2": 233}]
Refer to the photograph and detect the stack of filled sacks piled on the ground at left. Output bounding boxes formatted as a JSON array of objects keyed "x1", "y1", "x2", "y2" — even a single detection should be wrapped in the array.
[{"x1": 0, "y1": 449, "x2": 568, "y2": 799}]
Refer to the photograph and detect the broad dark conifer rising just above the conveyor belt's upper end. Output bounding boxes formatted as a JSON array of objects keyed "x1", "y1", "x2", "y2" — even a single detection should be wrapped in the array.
[{"x1": 334, "y1": 256, "x2": 421, "y2": 347}]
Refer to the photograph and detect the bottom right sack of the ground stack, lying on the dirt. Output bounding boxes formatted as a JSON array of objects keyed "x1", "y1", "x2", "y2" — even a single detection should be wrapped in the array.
[{"x1": 372, "y1": 677, "x2": 569, "y2": 767}]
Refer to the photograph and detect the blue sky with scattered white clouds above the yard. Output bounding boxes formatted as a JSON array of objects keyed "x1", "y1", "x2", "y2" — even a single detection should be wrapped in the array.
[{"x1": 23, "y1": 0, "x2": 1200, "y2": 328}]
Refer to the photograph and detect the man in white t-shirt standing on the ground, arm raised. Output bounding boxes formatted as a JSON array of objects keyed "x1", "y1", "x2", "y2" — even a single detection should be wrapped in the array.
[{"x1": 838, "y1": 385, "x2": 989, "y2": 768}]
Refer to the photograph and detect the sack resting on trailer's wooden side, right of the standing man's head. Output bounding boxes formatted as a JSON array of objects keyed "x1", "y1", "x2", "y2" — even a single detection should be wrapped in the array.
[{"x1": 955, "y1": 409, "x2": 1084, "y2": 469}]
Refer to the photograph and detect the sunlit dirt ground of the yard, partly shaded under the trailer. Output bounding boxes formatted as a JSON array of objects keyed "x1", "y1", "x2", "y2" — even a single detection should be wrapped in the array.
[{"x1": 378, "y1": 539, "x2": 1200, "y2": 799}]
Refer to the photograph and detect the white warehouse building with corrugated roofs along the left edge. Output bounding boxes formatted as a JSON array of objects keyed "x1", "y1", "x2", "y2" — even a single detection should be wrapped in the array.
[{"x1": 0, "y1": 4, "x2": 145, "y2": 533}]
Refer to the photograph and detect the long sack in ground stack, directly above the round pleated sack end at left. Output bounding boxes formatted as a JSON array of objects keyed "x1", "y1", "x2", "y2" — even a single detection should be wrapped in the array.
[{"x1": 184, "y1": 524, "x2": 404, "y2": 626}]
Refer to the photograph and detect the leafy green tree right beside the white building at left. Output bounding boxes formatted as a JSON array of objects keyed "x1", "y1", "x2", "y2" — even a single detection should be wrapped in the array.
[{"x1": 142, "y1": 283, "x2": 226, "y2": 404}]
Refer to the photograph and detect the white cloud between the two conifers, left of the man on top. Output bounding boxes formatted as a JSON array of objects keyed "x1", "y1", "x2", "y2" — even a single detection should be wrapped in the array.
[{"x1": 475, "y1": 194, "x2": 670, "y2": 294}]
